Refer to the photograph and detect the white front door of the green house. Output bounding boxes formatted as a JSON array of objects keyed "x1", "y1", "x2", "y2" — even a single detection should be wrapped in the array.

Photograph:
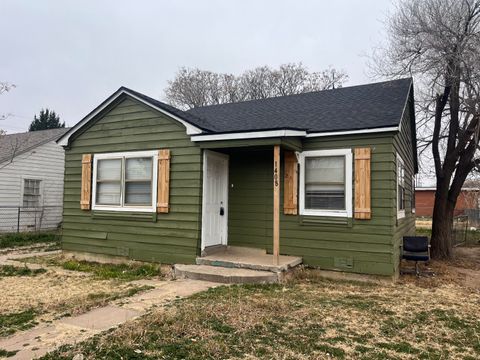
[{"x1": 201, "y1": 150, "x2": 228, "y2": 250}]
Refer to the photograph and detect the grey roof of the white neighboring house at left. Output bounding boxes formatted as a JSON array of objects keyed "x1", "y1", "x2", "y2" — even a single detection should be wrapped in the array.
[{"x1": 0, "y1": 128, "x2": 68, "y2": 163}]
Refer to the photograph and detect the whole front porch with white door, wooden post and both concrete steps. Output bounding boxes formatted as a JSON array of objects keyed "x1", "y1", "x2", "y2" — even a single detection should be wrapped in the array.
[{"x1": 175, "y1": 139, "x2": 302, "y2": 283}]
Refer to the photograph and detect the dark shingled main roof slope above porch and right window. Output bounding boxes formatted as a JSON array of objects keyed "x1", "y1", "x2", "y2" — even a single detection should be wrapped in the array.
[{"x1": 187, "y1": 78, "x2": 412, "y2": 133}]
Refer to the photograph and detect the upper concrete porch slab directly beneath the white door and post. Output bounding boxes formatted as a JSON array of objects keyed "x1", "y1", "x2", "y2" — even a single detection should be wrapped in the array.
[{"x1": 196, "y1": 246, "x2": 302, "y2": 273}]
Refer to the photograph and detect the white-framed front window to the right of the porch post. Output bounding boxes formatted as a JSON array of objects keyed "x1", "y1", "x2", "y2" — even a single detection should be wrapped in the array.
[{"x1": 299, "y1": 149, "x2": 352, "y2": 217}]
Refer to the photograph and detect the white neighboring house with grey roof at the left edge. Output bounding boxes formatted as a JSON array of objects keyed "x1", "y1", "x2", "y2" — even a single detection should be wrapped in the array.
[{"x1": 0, "y1": 129, "x2": 67, "y2": 232}]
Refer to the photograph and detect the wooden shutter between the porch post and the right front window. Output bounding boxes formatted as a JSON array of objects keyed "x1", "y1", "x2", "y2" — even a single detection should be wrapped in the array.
[{"x1": 283, "y1": 151, "x2": 298, "y2": 215}]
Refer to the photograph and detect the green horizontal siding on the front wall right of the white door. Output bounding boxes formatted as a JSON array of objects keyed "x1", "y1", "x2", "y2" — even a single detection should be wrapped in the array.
[{"x1": 228, "y1": 134, "x2": 396, "y2": 275}]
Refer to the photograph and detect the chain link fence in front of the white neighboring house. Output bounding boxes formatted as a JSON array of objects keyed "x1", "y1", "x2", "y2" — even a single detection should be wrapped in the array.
[{"x1": 0, "y1": 206, "x2": 62, "y2": 233}]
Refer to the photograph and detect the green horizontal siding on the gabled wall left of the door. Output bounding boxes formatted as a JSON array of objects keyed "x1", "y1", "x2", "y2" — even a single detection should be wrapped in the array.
[{"x1": 62, "y1": 99, "x2": 202, "y2": 263}]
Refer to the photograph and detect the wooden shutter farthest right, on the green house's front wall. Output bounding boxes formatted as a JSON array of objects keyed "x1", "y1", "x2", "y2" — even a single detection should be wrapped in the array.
[{"x1": 355, "y1": 148, "x2": 372, "y2": 219}]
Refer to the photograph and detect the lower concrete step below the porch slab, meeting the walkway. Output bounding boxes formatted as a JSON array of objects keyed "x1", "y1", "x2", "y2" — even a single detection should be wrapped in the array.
[{"x1": 174, "y1": 264, "x2": 281, "y2": 284}]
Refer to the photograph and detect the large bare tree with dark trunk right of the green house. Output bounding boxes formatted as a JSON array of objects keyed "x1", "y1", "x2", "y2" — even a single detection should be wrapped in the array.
[{"x1": 376, "y1": 0, "x2": 480, "y2": 258}]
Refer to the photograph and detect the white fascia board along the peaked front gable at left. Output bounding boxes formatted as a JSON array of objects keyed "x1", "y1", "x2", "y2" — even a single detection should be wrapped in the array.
[{"x1": 57, "y1": 89, "x2": 202, "y2": 146}]
